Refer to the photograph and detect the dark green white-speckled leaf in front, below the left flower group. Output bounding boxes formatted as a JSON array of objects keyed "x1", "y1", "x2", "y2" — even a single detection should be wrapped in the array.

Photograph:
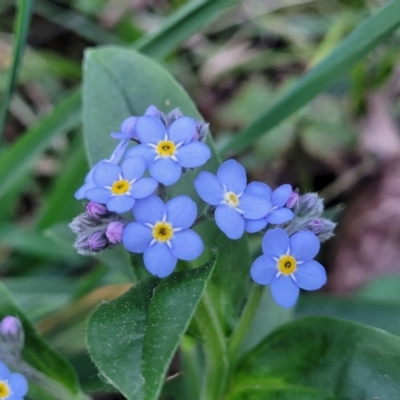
[{"x1": 87, "y1": 259, "x2": 215, "y2": 400}]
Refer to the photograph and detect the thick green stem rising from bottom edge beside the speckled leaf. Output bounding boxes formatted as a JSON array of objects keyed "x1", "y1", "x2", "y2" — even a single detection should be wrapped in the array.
[{"x1": 195, "y1": 293, "x2": 228, "y2": 400}]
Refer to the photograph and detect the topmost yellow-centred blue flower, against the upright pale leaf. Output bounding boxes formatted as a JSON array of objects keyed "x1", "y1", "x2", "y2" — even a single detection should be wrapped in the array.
[{"x1": 127, "y1": 116, "x2": 211, "y2": 186}]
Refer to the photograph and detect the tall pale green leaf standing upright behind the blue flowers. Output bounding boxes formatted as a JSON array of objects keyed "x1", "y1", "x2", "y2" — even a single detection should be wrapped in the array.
[{"x1": 83, "y1": 47, "x2": 249, "y2": 330}]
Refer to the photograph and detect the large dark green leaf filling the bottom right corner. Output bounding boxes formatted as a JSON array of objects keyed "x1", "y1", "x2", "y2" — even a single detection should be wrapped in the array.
[{"x1": 233, "y1": 317, "x2": 400, "y2": 400}]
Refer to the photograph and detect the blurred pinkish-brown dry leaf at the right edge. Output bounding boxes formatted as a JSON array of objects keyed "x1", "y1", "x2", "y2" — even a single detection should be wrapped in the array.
[{"x1": 328, "y1": 93, "x2": 400, "y2": 294}]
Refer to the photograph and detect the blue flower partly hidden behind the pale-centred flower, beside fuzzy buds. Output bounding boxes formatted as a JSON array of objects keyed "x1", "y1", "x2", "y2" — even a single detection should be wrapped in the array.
[{"x1": 245, "y1": 182, "x2": 294, "y2": 233}]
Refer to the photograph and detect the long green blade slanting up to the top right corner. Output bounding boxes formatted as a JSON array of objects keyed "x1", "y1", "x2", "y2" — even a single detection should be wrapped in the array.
[{"x1": 223, "y1": 0, "x2": 400, "y2": 152}]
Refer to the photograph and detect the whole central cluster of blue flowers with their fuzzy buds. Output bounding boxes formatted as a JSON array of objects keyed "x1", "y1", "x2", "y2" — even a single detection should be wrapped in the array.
[{"x1": 70, "y1": 106, "x2": 334, "y2": 307}]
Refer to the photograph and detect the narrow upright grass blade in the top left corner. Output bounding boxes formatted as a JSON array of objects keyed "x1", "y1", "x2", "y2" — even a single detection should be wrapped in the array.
[{"x1": 0, "y1": 0, "x2": 33, "y2": 144}]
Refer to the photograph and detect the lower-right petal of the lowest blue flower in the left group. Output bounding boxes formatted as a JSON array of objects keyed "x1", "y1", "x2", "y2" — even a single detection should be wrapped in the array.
[{"x1": 171, "y1": 229, "x2": 204, "y2": 261}]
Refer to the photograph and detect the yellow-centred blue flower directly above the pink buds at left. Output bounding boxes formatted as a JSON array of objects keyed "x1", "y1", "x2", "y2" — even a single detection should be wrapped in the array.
[{"x1": 85, "y1": 157, "x2": 157, "y2": 213}]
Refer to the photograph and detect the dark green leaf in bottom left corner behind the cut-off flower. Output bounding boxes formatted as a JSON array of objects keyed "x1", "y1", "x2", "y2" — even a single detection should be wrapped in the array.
[{"x1": 0, "y1": 283, "x2": 83, "y2": 400}]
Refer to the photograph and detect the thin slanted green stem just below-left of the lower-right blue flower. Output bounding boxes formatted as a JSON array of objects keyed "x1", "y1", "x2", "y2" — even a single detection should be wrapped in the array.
[{"x1": 228, "y1": 283, "x2": 264, "y2": 366}]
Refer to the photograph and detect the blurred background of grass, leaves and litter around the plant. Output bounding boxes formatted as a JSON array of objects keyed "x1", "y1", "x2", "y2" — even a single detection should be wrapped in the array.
[{"x1": 0, "y1": 0, "x2": 400, "y2": 399}]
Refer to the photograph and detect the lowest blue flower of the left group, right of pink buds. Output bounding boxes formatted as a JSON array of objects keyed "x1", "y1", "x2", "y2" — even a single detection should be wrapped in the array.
[{"x1": 122, "y1": 196, "x2": 204, "y2": 278}]
